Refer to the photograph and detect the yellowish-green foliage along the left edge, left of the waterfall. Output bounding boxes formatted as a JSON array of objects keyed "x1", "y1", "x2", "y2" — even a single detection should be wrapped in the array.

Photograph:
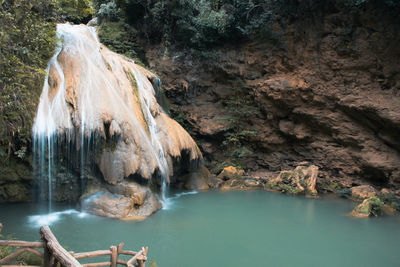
[{"x1": 0, "y1": 0, "x2": 57, "y2": 162}]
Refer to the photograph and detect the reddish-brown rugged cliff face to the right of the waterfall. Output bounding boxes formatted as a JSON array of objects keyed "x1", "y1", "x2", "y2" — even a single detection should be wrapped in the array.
[{"x1": 146, "y1": 5, "x2": 400, "y2": 193}]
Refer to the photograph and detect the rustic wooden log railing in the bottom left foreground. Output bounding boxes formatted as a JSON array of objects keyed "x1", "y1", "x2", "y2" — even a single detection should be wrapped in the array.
[{"x1": 0, "y1": 223, "x2": 148, "y2": 267}]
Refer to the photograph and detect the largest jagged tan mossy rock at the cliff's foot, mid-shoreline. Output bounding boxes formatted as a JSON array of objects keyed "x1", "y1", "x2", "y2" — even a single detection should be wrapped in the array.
[{"x1": 265, "y1": 165, "x2": 318, "y2": 195}]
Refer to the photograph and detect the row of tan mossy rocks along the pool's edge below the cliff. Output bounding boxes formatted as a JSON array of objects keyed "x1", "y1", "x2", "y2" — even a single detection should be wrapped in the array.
[{"x1": 209, "y1": 165, "x2": 400, "y2": 218}]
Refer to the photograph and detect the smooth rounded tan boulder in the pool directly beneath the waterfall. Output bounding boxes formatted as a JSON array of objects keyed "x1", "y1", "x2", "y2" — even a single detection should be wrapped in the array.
[{"x1": 81, "y1": 182, "x2": 162, "y2": 219}]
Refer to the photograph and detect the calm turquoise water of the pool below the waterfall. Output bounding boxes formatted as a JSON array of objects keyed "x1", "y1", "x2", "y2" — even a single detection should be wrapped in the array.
[{"x1": 0, "y1": 191, "x2": 400, "y2": 267}]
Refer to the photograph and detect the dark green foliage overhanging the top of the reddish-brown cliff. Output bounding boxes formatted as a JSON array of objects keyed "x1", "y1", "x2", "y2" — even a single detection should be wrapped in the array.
[{"x1": 94, "y1": 0, "x2": 400, "y2": 50}]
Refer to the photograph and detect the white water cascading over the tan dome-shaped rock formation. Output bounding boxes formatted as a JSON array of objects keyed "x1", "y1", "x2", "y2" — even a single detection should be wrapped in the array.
[{"x1": 33, "y1": 24, "x2": 201, "y2": 213}]
